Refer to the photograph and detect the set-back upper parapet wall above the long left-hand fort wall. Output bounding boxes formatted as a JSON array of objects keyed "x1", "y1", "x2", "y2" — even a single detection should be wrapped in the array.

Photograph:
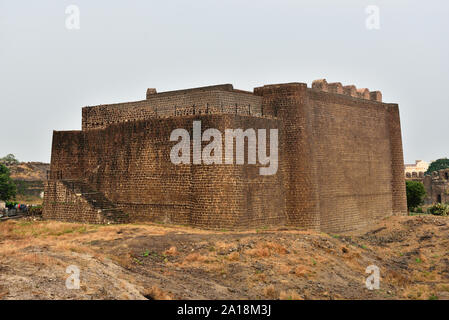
[{"x1": 82, "y1": 84, "x2": 262, "y2": 130}]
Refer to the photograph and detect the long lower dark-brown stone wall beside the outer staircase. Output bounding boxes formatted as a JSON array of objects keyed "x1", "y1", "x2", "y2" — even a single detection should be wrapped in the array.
[{"x1": 46, "y1": 114, "x2": 285, "y2": 228}]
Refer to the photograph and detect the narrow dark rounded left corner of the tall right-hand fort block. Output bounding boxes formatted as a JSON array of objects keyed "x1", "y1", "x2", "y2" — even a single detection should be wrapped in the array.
[{"x1": 254, "y1": 83, "x2": 320, "y2": 230}]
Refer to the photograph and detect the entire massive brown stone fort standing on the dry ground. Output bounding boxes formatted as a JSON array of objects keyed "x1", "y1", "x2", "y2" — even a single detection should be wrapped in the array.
[{"x1": 43, "y1": 79, "x2": 407, "y2": 232}]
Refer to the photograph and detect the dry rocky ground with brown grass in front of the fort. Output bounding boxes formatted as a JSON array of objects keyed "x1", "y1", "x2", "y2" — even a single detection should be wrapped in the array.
[{"x1": 0, "y1": 216, "x2": 449, "y2": 299}]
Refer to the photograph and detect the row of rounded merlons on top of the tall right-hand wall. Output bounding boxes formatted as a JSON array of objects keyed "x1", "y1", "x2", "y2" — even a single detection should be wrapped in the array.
[{"x1": 312, "y1": 79, "x2": 382, "y2": 102}]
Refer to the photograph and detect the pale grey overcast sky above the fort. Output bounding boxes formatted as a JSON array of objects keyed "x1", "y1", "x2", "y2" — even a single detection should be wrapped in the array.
[{"x1": 0, "y1": 0, "x2": 449, "y2": 162}]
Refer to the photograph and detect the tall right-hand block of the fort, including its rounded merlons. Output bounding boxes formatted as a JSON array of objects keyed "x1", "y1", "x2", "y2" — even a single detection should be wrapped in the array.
[{"x1": 255, "y1": 80, "x2": 407, "y2": 232}]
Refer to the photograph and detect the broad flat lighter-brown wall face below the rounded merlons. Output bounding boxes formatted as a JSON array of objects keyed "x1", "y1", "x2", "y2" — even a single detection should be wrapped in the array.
[{"x1": 307, "y1": 90, "x2": 393, "y2": 232}]
